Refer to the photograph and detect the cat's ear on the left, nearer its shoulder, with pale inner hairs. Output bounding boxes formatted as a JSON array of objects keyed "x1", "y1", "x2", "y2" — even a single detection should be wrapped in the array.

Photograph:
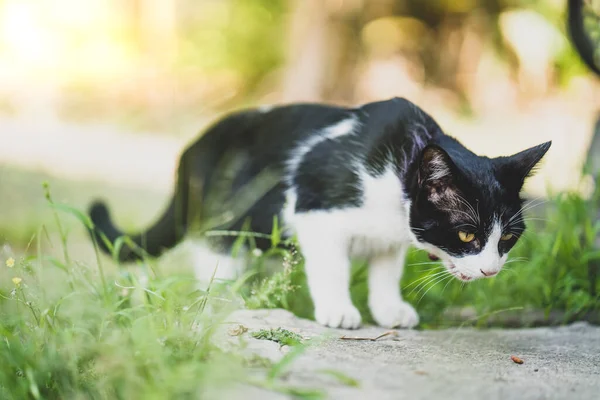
[{"x1": 418, "y1": 145, "x2": 456, "y2": 187}]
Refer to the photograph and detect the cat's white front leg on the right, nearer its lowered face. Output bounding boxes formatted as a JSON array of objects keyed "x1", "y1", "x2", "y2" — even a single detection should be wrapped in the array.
[{"x1": 369, "y1": 246, "x2": 419, "y2": 328}]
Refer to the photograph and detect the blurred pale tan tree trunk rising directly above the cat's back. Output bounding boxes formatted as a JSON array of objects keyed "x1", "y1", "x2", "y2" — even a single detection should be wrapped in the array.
[{"x1": 282, "y1": 0, "x2": 363, "y2": 103}]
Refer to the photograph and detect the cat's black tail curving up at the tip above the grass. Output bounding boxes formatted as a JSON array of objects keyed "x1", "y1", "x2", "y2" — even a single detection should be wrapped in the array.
[{"x1": 89, "y1": 158, "x2": 189, "y2": 262}]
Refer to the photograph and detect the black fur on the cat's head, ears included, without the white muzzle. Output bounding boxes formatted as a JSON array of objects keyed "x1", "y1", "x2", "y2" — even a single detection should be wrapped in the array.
[{"x1": 410, "y1": 141, "x2": 551, "y2": 256}]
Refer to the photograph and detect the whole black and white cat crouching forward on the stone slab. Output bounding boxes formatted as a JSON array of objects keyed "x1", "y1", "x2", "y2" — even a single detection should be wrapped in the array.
[{"x1": 90, "y1": 98, "x2": 551, "y2": 328}]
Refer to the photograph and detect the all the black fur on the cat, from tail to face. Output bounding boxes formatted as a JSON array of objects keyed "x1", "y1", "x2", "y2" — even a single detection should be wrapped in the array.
[{"x1": 90, "y1": 98, "x2": 550, "y2": 261}]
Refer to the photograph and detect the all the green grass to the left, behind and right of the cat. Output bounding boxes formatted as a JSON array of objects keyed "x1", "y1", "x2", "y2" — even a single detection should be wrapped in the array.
[{"x1": 0, "y1": 184, "x2": 600, "y2": 399}]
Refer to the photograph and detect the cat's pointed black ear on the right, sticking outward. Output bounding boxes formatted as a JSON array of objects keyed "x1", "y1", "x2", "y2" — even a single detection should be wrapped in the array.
[{"x1": 494, "y1": 141, "x2": 552, "y2": 192}]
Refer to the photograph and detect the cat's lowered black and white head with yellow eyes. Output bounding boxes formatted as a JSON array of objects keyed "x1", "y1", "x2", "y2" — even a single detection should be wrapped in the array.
[{"x1": 410, "y1": 142, "x2": 551, "y2": 281}]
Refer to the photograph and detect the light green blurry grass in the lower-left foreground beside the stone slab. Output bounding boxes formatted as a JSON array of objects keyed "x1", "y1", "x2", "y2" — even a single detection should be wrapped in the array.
[{"x1": 0, "y1": 186, "x2": 316, "y2": 400}]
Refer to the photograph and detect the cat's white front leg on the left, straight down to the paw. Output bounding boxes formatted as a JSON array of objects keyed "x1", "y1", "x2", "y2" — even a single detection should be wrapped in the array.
[{"x1": 297, "y1": 226, "x2": 361, "y2": 329}]
